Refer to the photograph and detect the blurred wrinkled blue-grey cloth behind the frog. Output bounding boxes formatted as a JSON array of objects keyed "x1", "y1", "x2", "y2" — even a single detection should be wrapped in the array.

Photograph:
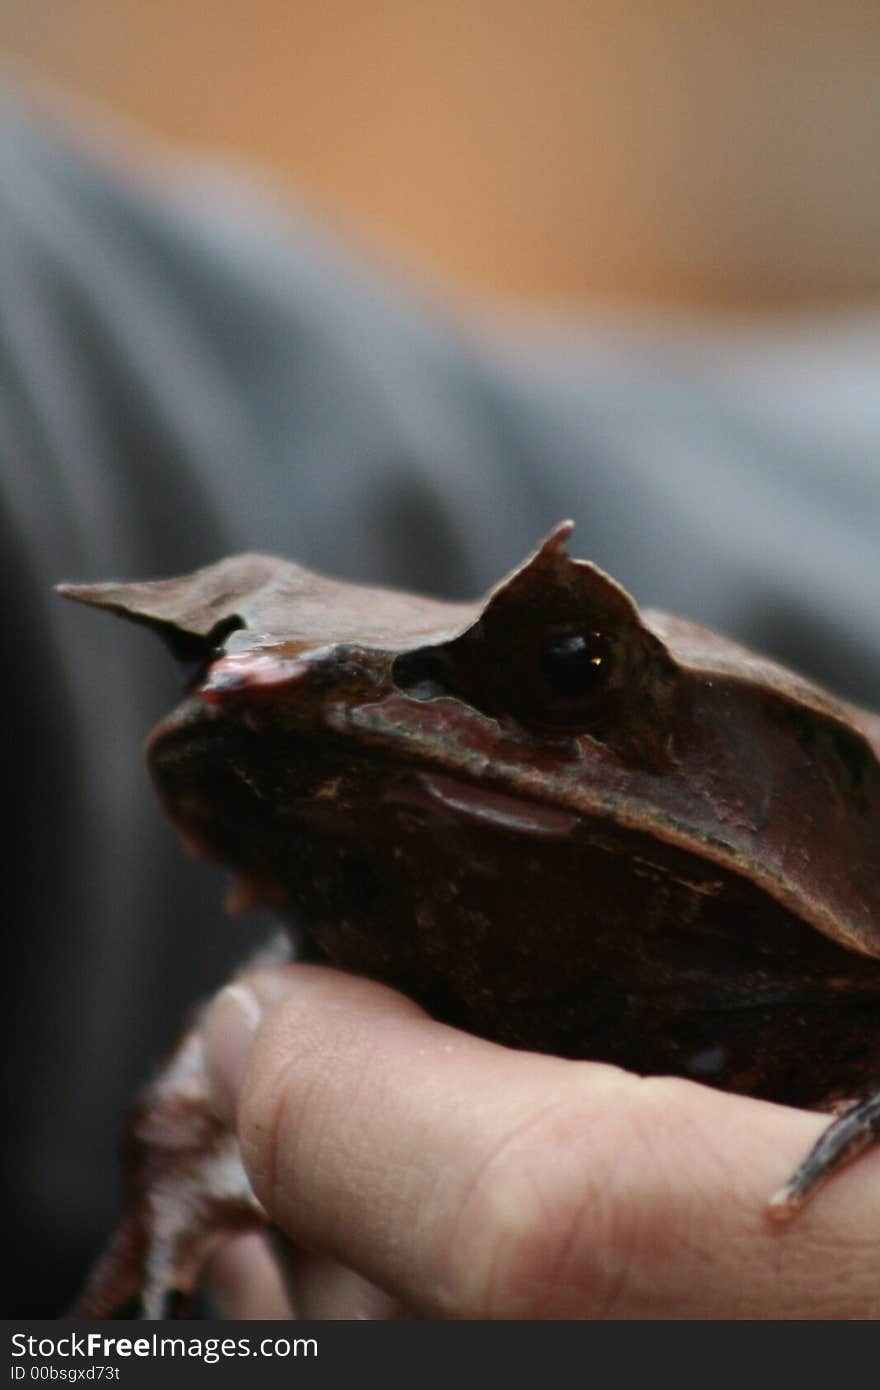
[{"x1": 0, "y1": 89, "x2": 880, "y2": 1315}]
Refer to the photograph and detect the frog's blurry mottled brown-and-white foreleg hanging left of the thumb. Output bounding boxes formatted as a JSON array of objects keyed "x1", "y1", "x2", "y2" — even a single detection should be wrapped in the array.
[{"x1": 72, "y1": 1029, "x2": 266, "y2": 1319}]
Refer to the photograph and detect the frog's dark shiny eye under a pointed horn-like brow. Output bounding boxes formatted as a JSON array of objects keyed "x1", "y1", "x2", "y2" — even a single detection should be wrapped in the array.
[{"x1": 392, "y1": 542, "x2": 680, "y2": 769}]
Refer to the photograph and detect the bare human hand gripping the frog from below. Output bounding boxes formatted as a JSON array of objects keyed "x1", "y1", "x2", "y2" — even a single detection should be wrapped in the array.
[{"x1": 206, "y1": 965, "x2": 880, "y2": 1319}]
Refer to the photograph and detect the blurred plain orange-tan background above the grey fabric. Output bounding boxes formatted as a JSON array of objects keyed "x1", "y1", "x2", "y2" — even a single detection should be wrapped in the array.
[{"x1": 0, "y1": 0, "x2": 880, "y2": 310}]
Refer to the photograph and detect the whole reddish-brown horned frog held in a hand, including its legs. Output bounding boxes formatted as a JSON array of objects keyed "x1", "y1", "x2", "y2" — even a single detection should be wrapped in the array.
[{"x1": 60, "y1": 521, "x2": 880, "y2": 1318}]
